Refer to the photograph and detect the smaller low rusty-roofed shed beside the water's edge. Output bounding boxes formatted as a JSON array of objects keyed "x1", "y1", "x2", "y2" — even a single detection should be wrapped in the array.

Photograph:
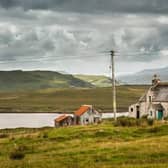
[{"x1": 54, "y1": 114, "x2": 73, "y2": 127}]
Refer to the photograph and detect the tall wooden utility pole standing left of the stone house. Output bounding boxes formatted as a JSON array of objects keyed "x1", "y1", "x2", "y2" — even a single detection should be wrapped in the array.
[{"x1": 110, "y1": 50, "x2": 117, "y2": 121}]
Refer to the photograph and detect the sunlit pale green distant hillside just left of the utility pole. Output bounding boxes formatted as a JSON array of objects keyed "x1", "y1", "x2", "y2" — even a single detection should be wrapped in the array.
[{"x1": 75, "y1": 75, "x2": 111, "y2": 87}]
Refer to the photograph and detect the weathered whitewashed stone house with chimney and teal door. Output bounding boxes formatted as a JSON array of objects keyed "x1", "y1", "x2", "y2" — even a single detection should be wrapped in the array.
[{"x1": 129, "y1": 75, "x2": 168, "y2": 120}]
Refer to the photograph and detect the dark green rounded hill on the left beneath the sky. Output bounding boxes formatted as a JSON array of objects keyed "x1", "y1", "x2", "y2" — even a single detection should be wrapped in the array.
[{"x1": 0, "y1": 70, "x2": 93, "y2": 91}]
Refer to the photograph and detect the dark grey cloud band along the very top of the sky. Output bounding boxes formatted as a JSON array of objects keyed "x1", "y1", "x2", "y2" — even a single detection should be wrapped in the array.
[{"x1": 0, "y1": 0, "x2": 168, "y2": 13}]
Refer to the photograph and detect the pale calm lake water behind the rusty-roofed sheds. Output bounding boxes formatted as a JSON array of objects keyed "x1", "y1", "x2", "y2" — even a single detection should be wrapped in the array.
[{"x1": 0, "y1": 112, "x2": 128, "y2": 129}]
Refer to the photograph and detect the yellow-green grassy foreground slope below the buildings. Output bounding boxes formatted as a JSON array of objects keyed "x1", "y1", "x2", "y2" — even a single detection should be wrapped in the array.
[{"x1": 0, "y1": 121, "x2": 168, "y2": 168}]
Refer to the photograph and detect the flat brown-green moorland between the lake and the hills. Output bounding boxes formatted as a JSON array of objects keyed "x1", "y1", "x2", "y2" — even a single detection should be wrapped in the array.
[{"x1": 0, "y1": 86, "x2": 148, "y2": 112}]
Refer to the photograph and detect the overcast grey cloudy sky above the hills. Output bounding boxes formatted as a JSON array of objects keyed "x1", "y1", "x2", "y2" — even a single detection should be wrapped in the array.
[{"x1": 0, "y1": 0, "x2": 168, "y2": 75}]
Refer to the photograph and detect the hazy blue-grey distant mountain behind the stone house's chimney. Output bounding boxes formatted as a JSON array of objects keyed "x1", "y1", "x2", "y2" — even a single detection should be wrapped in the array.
[{"x1": 117, "y1": 67, "x2": 168, "y2": 84}]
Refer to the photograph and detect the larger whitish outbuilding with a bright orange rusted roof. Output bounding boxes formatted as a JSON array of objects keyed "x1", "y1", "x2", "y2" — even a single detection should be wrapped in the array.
[{"x1": 74, "y1": 105, "x2": 102, "y2": 125}]
